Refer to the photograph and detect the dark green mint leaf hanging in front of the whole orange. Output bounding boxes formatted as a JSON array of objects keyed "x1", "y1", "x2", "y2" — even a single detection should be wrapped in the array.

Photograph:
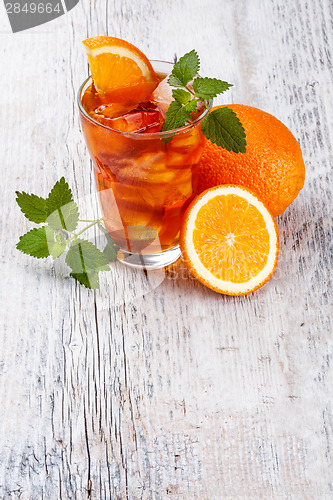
[{"x1": 201, "y1": 107, "x2": 246, "y2": 153}]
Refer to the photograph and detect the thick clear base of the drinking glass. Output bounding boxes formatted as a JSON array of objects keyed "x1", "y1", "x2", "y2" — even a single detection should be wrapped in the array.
[{"x1": 118, "y1": 245, "x2": 180, "y2": 271}]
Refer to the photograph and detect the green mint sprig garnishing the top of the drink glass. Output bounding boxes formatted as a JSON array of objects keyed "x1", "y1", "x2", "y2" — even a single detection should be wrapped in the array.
[{"x1": 161, "y1": 50, "x2": 246, "y2": 153}]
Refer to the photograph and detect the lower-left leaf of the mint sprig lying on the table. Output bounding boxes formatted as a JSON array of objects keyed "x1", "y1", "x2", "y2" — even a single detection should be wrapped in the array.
[{"x1": 16, "y1": 226, "x2": 54, "y2": 259}]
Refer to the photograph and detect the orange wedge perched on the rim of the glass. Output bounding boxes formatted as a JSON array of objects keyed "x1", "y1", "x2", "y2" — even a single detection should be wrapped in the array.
[{"x1": 83, "y1": 36, "x2": 159, "y2": 102}]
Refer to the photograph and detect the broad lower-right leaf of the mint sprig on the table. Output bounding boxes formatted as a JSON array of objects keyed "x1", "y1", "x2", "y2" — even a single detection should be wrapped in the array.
[{"x1": 66, "y1": 238, "x2": 110, "y2": 274}]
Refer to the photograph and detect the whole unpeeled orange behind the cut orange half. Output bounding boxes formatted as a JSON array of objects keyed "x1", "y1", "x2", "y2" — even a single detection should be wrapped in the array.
[{"x1": 198, "y1": 104, "x2": 305, "y2": 217}]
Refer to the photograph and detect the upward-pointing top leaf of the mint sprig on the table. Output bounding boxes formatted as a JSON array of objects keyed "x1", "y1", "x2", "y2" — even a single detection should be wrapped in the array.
[{"x1": 46, "y1": 177, "x2": 79, "y2": 231}]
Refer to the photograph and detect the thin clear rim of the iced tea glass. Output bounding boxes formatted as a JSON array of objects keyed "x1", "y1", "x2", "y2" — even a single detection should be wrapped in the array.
[{"x1": 77, "y1": 59, "x2": 213, "y2": 139}]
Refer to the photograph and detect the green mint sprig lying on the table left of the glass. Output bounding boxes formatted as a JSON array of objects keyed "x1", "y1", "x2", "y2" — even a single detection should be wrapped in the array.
[{"x1": 16, "y1": 177, "x2": 119, "y2": 289}]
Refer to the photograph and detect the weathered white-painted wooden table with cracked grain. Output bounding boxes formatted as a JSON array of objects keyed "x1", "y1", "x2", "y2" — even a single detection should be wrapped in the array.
[{"x1": 0, "y1": 0, "x2": 333, "y2": 500}]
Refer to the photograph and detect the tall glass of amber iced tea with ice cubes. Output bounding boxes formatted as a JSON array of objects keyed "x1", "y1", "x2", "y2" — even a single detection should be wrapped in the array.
[{"x1": 78, "y1": 61, "x2": 211, "y2": 269}]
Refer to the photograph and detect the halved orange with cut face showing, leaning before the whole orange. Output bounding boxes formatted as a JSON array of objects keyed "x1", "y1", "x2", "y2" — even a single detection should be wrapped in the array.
[{"x1": 180, "y1": 185, "x2": 279, "y2": 295}]
